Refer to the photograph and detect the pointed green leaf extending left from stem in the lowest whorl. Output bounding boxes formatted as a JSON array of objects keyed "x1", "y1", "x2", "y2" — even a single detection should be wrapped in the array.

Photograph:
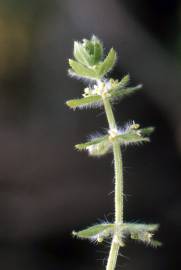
[{"x1": 72, "y1": 223, "x2": 114, "y2": 239}]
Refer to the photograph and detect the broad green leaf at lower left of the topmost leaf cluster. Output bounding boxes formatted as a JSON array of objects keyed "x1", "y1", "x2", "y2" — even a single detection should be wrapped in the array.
[{"x1": 69, "y1": 59, "x2": 98, "y2": 80}]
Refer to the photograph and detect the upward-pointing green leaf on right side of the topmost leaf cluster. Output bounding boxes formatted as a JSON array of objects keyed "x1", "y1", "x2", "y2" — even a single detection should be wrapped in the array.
[{"x1": 97, "y1": 48, "x2": 117, "y2": 77}]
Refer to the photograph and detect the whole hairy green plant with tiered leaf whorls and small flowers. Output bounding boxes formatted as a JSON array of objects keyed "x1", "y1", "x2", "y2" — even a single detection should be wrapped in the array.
[{"x1": 66, "y1": 36, "x2": 161, "y2": 270}]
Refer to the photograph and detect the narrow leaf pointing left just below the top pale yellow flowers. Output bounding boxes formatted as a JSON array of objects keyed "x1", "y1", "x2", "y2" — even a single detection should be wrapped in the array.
[{"x1": 66, "y1": 95, "x2": 102, "y2": 109}]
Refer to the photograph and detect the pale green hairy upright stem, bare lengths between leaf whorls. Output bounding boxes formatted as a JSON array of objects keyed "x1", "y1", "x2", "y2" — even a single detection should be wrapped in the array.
[{"x1": 103, "y1": 98, "x2": 123, "y2": 270}]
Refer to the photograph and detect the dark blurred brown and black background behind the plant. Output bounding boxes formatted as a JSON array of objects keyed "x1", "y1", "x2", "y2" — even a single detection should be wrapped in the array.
[{"x1": 0, "y1": 0, "x2": 181, "y2": 270}]
